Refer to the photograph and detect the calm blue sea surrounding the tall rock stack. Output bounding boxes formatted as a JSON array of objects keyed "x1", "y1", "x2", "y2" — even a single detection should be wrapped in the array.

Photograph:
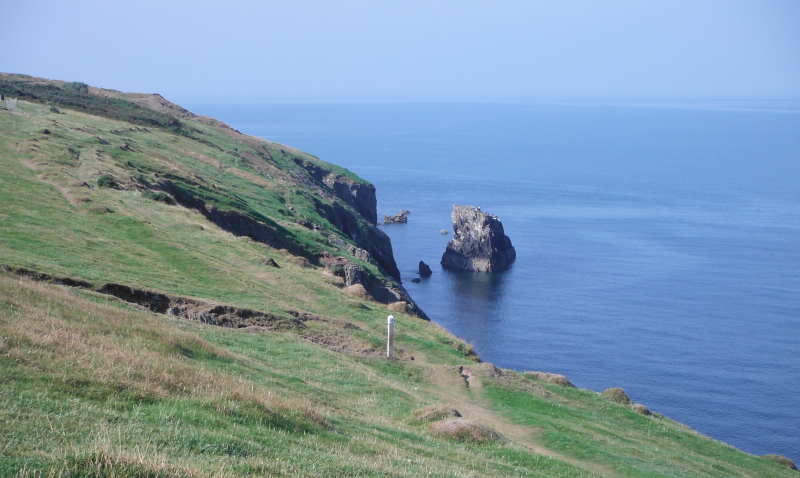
[{"x1": 183, "y1": 101, "x2": 800, "y2": 463}]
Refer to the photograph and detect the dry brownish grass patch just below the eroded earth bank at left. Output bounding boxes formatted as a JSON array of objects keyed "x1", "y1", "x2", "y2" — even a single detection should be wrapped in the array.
[{"x1": 0, "y1": 273, "x2": 327, "y2": 426}]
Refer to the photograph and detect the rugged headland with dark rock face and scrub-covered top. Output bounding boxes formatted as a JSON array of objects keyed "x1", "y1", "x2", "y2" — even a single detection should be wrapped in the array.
[{"x1": 0, "y1": 74, "x2": 427, "y2": 318}]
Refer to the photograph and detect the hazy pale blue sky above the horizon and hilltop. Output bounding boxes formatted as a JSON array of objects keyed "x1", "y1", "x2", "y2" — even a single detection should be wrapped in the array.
[{"x1": 0, "y1": 0, "x2": 800, "y2": 98}]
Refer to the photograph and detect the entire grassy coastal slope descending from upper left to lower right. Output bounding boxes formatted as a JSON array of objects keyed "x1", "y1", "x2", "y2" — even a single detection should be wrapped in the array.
[{"x1": 0, "y1": 95, "x2": 796, "y2": 477}]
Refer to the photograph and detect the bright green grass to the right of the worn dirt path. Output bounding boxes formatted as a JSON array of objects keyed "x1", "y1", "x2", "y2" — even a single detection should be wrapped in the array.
[{"x1": 484, "y1": 376, "x2": 785, "y2": 477}]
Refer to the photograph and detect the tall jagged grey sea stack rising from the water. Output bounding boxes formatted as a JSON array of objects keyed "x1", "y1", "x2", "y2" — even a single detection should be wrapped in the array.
[{"x1": 442, "y1": 204, "x2": 517, "y2": 272}]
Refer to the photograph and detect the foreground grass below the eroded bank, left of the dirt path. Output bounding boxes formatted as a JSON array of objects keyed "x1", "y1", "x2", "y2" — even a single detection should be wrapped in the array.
[{"x1": 0, "y1": 275, "x2": 588, "y2": 476}]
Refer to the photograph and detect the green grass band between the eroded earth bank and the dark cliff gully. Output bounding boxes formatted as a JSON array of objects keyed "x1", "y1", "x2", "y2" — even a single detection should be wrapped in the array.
[{"x1": 0, "y1": 106, "x2": 319, "y2": 312}]
